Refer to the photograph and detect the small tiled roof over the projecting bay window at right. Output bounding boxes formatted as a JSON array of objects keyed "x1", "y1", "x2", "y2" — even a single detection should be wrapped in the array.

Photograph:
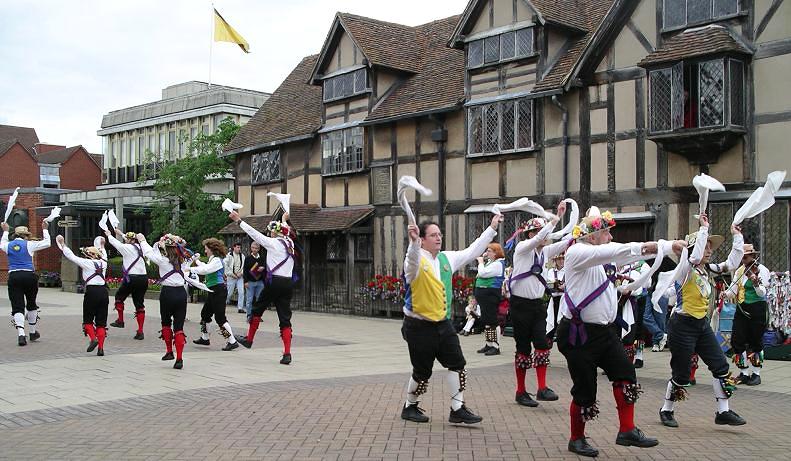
[{"x1": 637, "y1": 25, "x2": 753, "y2": 67}]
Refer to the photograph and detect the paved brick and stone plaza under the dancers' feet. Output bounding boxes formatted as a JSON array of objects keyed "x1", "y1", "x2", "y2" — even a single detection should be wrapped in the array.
[{"x1": 0, "y1": 288, "x2": 791, "y2": 461}]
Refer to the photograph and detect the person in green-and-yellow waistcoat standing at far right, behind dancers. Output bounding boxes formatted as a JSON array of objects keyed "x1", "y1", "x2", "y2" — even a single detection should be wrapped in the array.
[{"x1": 726, "y1": 243, "x2": 772, "y2": 386}]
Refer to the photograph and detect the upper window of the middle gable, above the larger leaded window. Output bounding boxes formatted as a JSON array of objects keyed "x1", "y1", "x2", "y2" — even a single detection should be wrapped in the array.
[{"x1": 467, "y1": 27, "x2": 535, "y2": 69}]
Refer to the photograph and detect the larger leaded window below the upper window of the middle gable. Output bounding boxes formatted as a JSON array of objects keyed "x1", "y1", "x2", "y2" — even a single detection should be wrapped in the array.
[{"x1": 467, "y1": 98, "x2": 534, "y2": 155}]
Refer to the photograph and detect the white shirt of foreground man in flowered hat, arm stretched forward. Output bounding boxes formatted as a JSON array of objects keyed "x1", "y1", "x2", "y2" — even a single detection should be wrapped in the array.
[{"x1": 560, "y1": 241, "x2": 653, "y2": 325}]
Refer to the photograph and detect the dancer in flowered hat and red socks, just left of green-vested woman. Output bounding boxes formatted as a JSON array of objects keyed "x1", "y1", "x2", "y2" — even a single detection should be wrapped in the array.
[{"x1": 136, "y1": 234, "x2": 188, "y2": 370}]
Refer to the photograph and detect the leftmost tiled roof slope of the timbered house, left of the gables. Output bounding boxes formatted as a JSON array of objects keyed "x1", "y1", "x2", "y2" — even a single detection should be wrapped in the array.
[{"x1": 225, "y1": 55, "x2": 322, "y2": 154}]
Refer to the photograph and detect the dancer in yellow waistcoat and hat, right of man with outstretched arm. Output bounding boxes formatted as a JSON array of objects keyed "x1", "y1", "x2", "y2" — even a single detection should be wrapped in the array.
[{"x1": 659, "y1": 213, "x2": 746, "y2": 427}]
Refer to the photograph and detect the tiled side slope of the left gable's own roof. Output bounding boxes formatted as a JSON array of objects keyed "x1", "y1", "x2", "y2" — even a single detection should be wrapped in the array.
[{"x1": 338, "y1": 13, "x2": 421, "y2": 72}]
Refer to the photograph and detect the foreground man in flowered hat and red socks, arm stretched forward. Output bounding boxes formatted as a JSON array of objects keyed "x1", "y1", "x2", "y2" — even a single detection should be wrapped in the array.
[{"x1": 557, "y1": 207, "x2": 683, "y2": 457}]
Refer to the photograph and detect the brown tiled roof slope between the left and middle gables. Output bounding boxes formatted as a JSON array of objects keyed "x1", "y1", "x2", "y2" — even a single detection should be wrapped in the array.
[{"x1": 366, "y1": 16, "x2": 465, "y2": 121}]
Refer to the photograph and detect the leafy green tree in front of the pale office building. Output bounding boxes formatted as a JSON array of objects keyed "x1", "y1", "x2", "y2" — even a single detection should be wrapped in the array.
[{"x1": 141, "y1": 117, "x2": 239, "y2": 246}]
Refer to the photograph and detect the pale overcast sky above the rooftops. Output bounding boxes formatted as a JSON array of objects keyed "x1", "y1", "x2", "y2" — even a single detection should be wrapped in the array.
[{"x1": 0, "y1": 0, "x2": 467, "y2": 153}]
